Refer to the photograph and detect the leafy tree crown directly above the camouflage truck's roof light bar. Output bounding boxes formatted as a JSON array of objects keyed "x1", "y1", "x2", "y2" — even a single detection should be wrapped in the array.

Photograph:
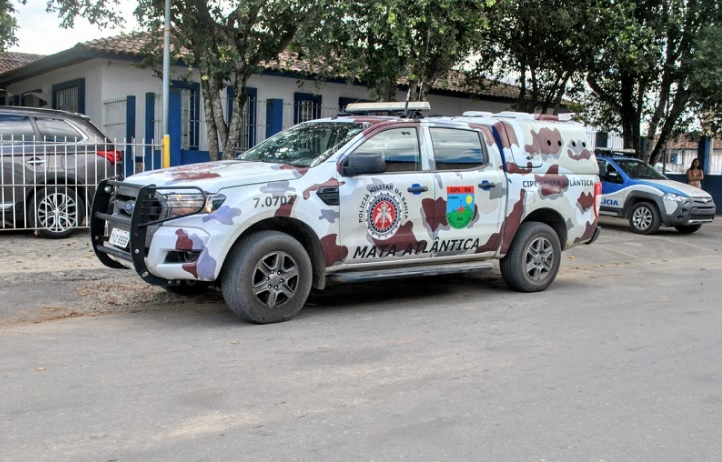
[{"x1": 299, "y1": 0, "x2": 486, "y2": 101}]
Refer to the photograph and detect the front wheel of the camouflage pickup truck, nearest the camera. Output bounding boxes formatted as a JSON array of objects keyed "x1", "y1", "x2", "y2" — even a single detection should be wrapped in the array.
[{"x1": 221, "y1": 231, "x2": 312, "y2": 324}]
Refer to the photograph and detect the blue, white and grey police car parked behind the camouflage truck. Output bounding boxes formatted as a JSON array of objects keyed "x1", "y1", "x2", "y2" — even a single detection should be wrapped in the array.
[{"x1": 596, "y1": 148, "x2": 716, "y2": 234}]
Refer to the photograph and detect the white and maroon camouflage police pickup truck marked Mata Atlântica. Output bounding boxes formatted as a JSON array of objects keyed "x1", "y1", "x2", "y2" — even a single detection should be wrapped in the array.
[{"x1": 90, "y1": 102, "x2": 602, "y2": 323}]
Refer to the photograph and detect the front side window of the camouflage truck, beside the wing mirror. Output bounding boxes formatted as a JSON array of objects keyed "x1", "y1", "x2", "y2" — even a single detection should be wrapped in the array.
[{"x1": 352, "y1": 127, "x2": 421, "y2": 172}]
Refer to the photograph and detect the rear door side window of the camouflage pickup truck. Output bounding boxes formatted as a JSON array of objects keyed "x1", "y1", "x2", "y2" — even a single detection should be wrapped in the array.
[{"x1": 429, "y1": 127, "x2": 487, "y2": 170}]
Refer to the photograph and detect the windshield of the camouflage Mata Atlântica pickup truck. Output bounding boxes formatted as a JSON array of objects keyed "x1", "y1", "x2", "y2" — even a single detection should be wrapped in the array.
[{"x1": 238, "y1": 122, "x2": 366, "y2": 167}]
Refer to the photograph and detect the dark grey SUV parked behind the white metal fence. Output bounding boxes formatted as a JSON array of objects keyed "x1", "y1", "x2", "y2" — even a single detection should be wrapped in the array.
[{"x1": 0, "y1": 106, "x2": 123, "y2": 238}]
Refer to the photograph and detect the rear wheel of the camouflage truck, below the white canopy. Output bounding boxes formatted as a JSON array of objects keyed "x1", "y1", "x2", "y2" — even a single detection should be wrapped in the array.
[{"x1": 499, "y1": 222, "x2": 562, "y2": 292}]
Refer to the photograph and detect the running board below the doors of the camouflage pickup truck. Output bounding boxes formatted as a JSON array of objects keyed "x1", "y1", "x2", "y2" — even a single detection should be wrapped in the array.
[{"x1": 326, "y1": 261, "x2": 494, "y2": 282}]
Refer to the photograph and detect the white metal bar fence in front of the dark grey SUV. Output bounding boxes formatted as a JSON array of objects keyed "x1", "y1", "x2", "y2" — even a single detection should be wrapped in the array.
[{"x1": 0, "y1": 135, "x2": 160, "y2": 233}]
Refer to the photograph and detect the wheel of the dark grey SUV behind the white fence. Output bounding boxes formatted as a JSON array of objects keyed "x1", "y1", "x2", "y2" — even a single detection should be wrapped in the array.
[{"x1": 28, "y1": 185, "x2": 85, "y2": 239}]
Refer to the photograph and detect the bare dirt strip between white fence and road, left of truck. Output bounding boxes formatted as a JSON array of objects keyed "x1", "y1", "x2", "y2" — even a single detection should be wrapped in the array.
[{"x1": 0, "y1": 230, "x2": 222, "y2": 326}]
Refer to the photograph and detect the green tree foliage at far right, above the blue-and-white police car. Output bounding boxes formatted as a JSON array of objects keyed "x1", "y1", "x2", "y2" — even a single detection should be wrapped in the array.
[{"x1": 586, "y1": 0, "x2": 722, "y2": 163}]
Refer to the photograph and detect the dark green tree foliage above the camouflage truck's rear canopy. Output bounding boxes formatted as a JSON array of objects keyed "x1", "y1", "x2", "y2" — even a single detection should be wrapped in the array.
[{"x1": 471, "y1": 0, "x2": 604, "y2": 113}]
